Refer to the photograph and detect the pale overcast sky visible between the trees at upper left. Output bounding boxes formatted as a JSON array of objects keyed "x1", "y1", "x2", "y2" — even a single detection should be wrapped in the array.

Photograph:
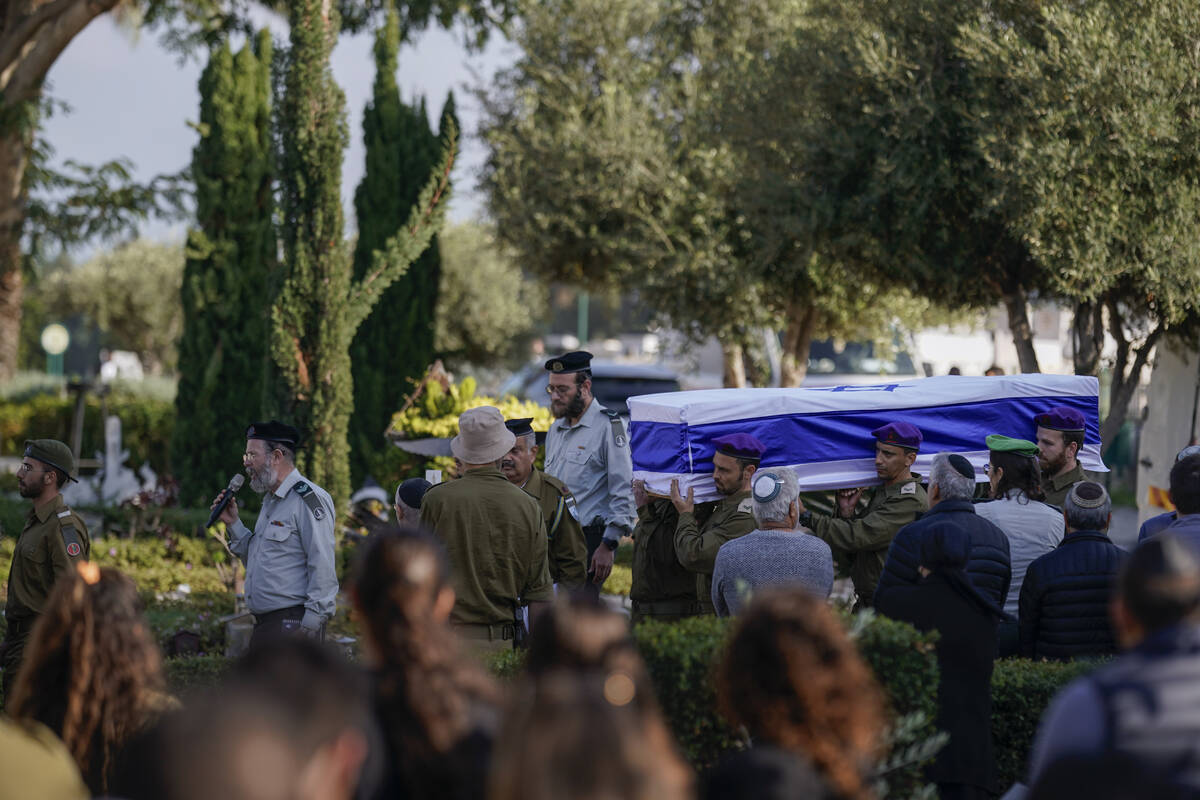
[{"x1": 42, "y1": 16, "x2": 516, "y2": 248}]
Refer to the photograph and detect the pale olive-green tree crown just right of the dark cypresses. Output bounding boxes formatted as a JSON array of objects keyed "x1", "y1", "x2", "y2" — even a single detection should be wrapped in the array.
[{"x1": 436, "y1": 222, "x2": 550, "y2": 365}]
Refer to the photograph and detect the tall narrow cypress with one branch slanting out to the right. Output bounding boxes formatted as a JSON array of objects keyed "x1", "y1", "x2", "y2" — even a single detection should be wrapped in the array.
[{"x1": 271, "y1": 0, "x2": 454, "y2": 513}]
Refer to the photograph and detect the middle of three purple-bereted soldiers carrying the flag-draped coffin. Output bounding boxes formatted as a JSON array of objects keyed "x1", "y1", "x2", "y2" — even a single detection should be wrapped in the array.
[{"x1": 798, "y1": 422, "x2": 929, "y2": 608}]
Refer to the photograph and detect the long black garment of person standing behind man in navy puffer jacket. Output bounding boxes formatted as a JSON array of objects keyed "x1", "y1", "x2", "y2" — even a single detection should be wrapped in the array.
[{"x1": 876, "y1": 573, "x2": 996, "y2": 792}]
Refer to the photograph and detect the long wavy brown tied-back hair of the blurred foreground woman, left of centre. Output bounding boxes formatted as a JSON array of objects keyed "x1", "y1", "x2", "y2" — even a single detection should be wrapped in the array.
[{"x1": 352, "y1": 527, "x2": 498, "y2": 795}]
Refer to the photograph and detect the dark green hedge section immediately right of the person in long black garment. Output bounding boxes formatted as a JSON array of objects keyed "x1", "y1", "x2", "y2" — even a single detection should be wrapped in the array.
[{"x1": 991, "y1": 658, "x2": 1103, "y2": 788}]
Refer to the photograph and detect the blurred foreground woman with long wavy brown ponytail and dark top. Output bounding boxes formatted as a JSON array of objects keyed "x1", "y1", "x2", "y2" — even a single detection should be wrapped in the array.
[{"x1": 350, "y1": 528, "x2": 498, "y2": 799}]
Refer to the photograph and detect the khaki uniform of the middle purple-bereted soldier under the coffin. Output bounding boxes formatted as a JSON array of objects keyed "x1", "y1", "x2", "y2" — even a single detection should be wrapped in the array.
[{"x1": 812, "y1": 475, "x2": 929, "y2": 608}]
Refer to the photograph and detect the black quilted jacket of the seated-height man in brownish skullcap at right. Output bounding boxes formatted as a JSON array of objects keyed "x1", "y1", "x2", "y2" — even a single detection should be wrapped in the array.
[{"x1": 1018, "y1": 530, "x2": 1126, "y2": 661}]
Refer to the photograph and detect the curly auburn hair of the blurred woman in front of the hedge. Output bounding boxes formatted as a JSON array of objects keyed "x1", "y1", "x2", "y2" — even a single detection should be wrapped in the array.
[{"x1": 716, "y1": 589, "x2": 884, "y2": 800}]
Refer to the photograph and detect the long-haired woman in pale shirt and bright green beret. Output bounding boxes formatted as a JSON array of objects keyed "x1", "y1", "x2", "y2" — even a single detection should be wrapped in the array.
[{"x1": 974, "y1": 434, "x2": 1063, "y2": 656}]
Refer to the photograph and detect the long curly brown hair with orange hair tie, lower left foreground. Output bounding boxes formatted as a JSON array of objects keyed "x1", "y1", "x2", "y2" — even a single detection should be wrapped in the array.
[{"x1": 11, "y1": 564, "x2": 167, "y2": 794}]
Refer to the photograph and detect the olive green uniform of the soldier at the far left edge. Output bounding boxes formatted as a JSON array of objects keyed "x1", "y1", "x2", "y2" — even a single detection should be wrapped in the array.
[{"x1": 2, "y1": 494, "x2": 91, "y2": 697}]
